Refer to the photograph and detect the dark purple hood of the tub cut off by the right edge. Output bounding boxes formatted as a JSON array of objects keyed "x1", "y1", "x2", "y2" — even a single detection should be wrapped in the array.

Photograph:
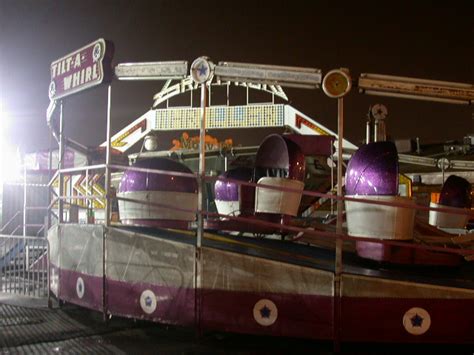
[{"x1": 439, "y1": 175, "x2": 471, "y2": 208}]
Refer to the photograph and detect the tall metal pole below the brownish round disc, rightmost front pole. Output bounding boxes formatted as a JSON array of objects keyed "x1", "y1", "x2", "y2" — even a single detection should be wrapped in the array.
[{"x1": 334, "y1": 97, "x2": 344, "y2": 351}]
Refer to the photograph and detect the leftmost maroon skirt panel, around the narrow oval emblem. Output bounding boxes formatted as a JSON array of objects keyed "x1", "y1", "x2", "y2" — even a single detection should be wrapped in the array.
[{"x1": 59, "y1": 269, "x2": 103, "y2": 311}]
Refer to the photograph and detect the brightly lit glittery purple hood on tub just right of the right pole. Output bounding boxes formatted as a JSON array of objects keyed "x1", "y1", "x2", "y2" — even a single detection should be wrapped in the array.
[{"x1": 346, "y1": 142, "x2": 398, "y2": 195}]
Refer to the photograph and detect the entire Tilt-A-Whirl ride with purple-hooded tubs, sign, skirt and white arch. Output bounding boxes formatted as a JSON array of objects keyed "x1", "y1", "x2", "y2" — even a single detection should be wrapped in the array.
[{"x1": 44, "y1": 40, "x2": 474, "y2": 347}]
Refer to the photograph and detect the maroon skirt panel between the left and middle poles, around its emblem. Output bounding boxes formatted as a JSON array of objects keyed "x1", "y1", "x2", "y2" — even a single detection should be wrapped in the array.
[{"x1": 107, "y1": 280, "x2": 195, "y2": 326}]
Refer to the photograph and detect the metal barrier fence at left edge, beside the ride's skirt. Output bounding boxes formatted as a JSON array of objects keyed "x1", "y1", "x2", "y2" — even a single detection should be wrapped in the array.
[{"x1": 0, "y1": 235, "x2": 48, "y2": 297}]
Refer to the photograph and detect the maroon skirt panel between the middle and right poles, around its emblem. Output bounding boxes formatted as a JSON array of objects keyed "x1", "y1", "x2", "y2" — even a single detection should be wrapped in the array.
[{"x1": 201, "y1": 289, "x2": 333, "y2": 339}]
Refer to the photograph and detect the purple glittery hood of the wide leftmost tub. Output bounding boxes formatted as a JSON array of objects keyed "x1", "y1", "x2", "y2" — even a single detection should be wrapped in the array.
[{"x1": 119, "y1": 158, "x2": 197, "y2": 192}]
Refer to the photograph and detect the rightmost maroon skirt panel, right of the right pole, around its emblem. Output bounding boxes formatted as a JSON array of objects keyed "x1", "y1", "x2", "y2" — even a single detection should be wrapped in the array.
[{"x1": 342, "y1": 297, "x2": 474, "y2": 344}]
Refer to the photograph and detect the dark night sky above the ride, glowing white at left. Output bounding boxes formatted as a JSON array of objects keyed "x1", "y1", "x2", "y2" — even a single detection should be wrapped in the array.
[{"x1": 0, "y1": 0, "x2": 474, "y2": 151}]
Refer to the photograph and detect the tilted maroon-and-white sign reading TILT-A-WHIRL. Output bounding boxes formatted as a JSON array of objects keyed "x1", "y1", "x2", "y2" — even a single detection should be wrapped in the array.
[{"x1": 49, "y1": 38, "x2": 114, "y2": 100}]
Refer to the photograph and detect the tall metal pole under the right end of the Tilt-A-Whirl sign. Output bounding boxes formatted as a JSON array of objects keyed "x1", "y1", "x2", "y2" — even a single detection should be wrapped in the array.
[{"x1": 102, "y1": 85, "x2": 112, "y2": 322}]
